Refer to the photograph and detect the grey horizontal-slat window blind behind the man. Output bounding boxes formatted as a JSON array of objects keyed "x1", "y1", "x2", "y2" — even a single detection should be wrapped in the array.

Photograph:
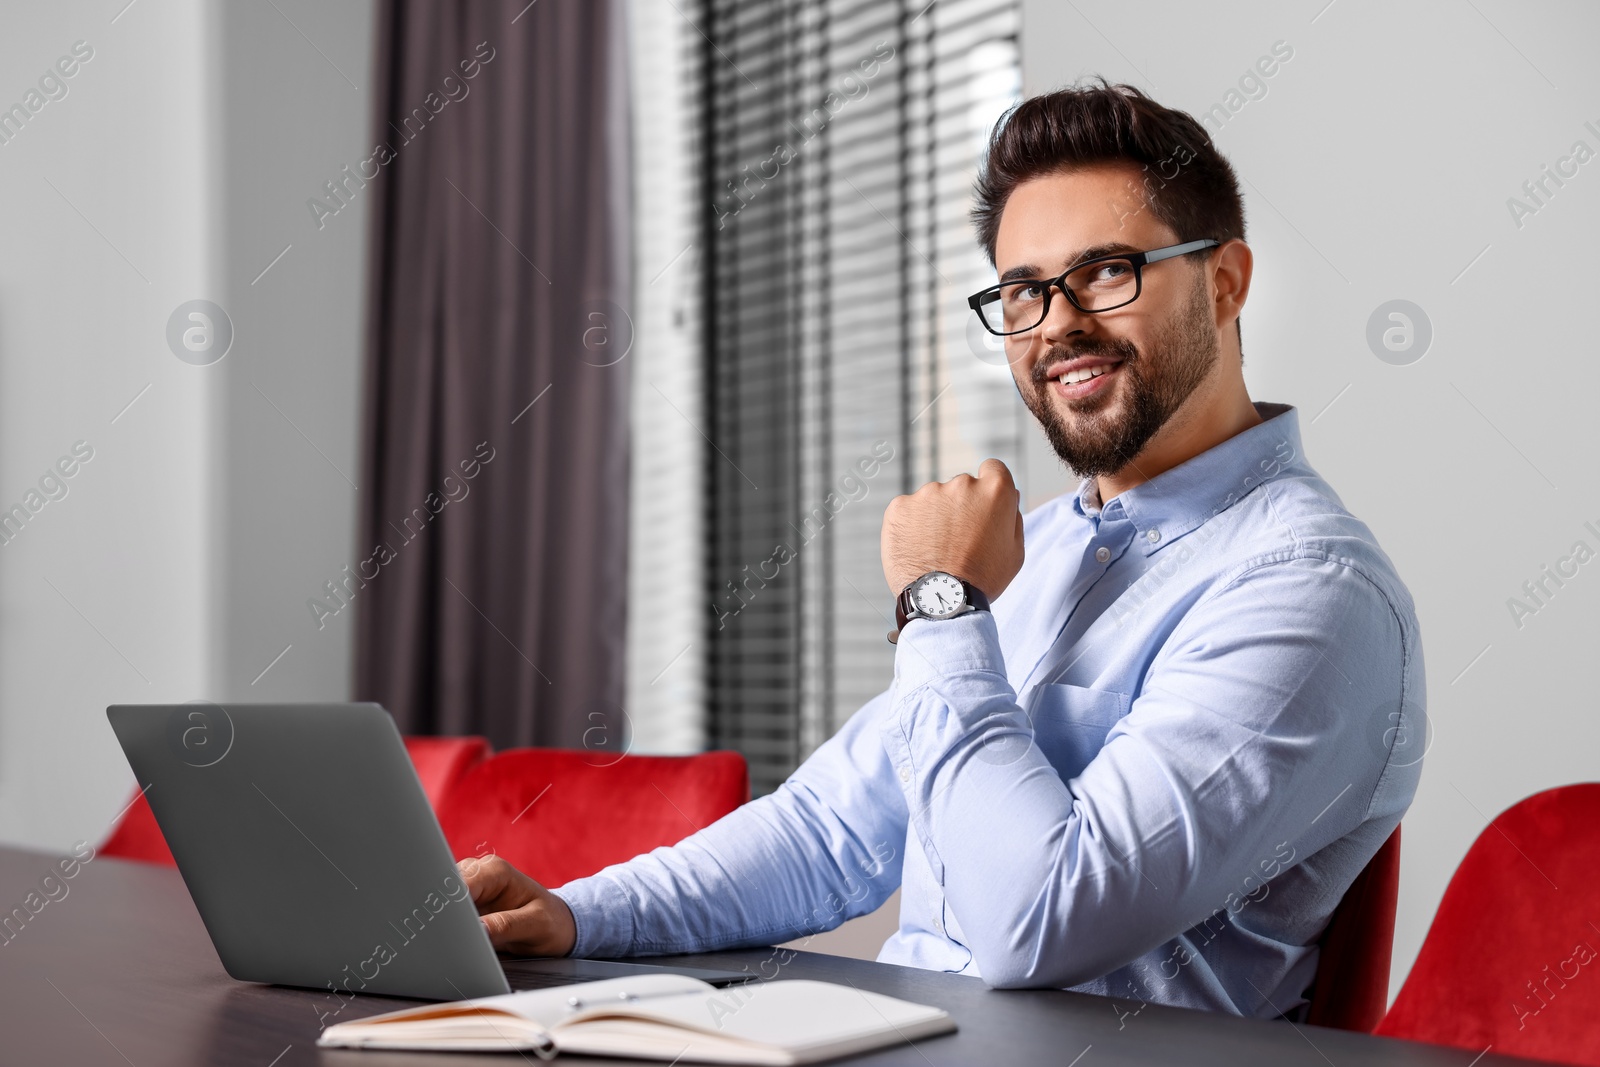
[{"x1": 700, "y1": 0, "x2": 1034, "y2": 793}]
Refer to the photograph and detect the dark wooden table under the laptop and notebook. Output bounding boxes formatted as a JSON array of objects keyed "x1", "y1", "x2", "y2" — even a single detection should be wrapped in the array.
[{"x1": 0, "y1": 848, "x2": 1548, "y2": 1067}]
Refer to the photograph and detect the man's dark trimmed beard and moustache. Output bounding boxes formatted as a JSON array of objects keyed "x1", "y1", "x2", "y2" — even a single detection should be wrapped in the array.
[{"x1": 1018, "y1": 274, "x2": 1221, "y2": 478}]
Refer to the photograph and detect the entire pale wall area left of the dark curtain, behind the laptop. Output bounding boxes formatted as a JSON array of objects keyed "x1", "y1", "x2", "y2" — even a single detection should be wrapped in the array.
[{"x1": 0, "y1": 0, "x2": 373, "y2": 848}]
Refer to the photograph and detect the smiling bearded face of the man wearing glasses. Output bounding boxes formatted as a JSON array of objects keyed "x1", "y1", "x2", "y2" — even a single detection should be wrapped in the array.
[{"x1": 995, "y1": 163, "x2": 1221, "y2": 477}]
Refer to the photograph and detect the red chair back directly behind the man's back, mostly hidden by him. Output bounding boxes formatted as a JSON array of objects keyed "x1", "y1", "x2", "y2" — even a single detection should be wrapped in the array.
[{"x1": 1306, "y1": 825, "x2": 1400, "y2": 1033}]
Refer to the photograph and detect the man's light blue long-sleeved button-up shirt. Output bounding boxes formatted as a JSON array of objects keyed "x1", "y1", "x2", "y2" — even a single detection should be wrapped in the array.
[{"x1": 560, "y1": 403, "x2": 1426, "y2": 1017}]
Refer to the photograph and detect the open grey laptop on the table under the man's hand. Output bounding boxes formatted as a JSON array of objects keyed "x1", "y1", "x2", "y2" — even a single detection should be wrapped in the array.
[{"x1": 106, "y1": 701, "x2": 754, "y2": 1000}]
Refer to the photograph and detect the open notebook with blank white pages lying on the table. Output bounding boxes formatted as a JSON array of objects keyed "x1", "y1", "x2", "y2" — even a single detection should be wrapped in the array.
[{"x1": 317, "y1": 974, "x2": 955, "y2": 1064}]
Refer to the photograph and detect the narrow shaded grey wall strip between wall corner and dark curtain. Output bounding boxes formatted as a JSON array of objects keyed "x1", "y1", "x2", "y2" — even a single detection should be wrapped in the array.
[{"x1": 213, "y1": 0, "x2": 372, "y2": 701}]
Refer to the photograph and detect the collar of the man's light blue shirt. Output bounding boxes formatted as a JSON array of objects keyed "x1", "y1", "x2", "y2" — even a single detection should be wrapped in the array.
[{"x1": 1072, "y1": 403, "x2": 1307, "y2": 555}]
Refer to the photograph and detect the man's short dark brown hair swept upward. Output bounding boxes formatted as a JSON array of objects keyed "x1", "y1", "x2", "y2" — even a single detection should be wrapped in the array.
[{"x1": 973, "y1": 77, "x2": 1245, "y2": 264}]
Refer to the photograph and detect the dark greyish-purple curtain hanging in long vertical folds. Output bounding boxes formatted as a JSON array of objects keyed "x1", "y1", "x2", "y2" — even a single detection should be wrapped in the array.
[{"x1": 356, "y1": 0, "x2": 632, "y2": 749}]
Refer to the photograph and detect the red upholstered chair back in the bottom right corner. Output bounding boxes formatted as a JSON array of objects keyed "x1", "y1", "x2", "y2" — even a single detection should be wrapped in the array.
[{"x1": 1378, "y1": 782, "x2": 1600, "y2": 1065}]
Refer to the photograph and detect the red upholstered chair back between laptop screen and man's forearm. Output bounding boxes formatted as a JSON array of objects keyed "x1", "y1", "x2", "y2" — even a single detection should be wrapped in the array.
[{"x1": 438, "y1": 749, "x2": 750, "y2": 886}]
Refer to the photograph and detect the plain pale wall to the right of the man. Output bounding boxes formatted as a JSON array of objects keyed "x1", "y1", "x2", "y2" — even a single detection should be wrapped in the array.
[{"x1": 1022, "y1": 0, "x2": 1600, "y2": 993}]
